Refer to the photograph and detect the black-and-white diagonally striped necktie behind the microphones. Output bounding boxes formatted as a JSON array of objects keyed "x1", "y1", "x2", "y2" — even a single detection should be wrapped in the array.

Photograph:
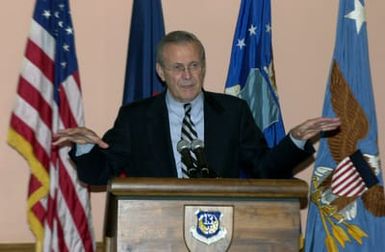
[{"x1": 181, "y1": 103, "x2": 198, "y2": 178}]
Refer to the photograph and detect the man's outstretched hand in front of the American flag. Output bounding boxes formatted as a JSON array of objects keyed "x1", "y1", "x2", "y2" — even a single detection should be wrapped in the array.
[{"x1": 52, "y1": 127, "x2": 109, "y2": 149}]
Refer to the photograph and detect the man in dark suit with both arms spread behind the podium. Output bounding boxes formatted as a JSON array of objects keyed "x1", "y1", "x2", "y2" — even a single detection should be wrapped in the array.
[{"x1": 54, "y1": 31, "x2": 340, "y2": 184}]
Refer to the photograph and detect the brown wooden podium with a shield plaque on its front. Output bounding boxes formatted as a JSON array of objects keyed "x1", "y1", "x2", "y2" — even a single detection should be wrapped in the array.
[{"x1": 104, "y1": 178, "x2": 308, "y2": 252}]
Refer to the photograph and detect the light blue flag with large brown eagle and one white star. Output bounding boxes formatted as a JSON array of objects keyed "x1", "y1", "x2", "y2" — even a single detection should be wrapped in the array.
[{"x1": 305, "y1": 0, "x2": 385, "y2": 252}]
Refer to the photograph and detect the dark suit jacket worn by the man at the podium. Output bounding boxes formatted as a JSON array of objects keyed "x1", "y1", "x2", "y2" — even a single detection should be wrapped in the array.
[{"x1": 71, "y1": 92, "x2": 314, "y2": 185}]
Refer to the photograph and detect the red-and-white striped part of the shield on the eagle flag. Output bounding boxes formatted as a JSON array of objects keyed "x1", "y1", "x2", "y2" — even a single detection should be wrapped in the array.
[{"x1": 331, "y1": 157, "x2": 367, "y2": 197}]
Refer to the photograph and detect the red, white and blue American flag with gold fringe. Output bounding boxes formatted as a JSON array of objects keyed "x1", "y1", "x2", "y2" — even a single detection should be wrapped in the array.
[{"x1": 8, "y1": 0, "x2": 95, "y2": 251}]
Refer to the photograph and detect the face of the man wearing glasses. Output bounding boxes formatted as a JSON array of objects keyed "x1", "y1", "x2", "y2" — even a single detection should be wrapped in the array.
[{"x1": 156, "y1": 43, "x2": 205, "y2": 102}]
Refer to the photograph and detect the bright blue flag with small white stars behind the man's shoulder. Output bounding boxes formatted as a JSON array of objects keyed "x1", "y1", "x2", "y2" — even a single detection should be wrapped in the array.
[{"x1": 225, "y1": 0, "x2": 285, "y2": 150}]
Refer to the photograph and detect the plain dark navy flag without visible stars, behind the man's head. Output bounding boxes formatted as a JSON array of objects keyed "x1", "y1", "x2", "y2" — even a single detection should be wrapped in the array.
[{"x1": 123, "y1": 0, "x2": 165, "y2": 105}]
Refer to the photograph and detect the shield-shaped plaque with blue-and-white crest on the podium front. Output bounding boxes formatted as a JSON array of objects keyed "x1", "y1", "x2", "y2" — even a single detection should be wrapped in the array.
[{"x1": 184, "y1": 206, "x2": 233, "y2": 251}]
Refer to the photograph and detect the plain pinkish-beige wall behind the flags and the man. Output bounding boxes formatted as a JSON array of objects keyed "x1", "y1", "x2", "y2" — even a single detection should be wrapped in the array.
[{"x1": 0, "y1": 0, "x2": 385, "y2": 242}]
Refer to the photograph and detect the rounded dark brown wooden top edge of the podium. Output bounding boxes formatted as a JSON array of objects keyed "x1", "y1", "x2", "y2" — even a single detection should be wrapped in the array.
[{"x1": 108, "y1": 178, "x2": 308, "y2": 200}]
